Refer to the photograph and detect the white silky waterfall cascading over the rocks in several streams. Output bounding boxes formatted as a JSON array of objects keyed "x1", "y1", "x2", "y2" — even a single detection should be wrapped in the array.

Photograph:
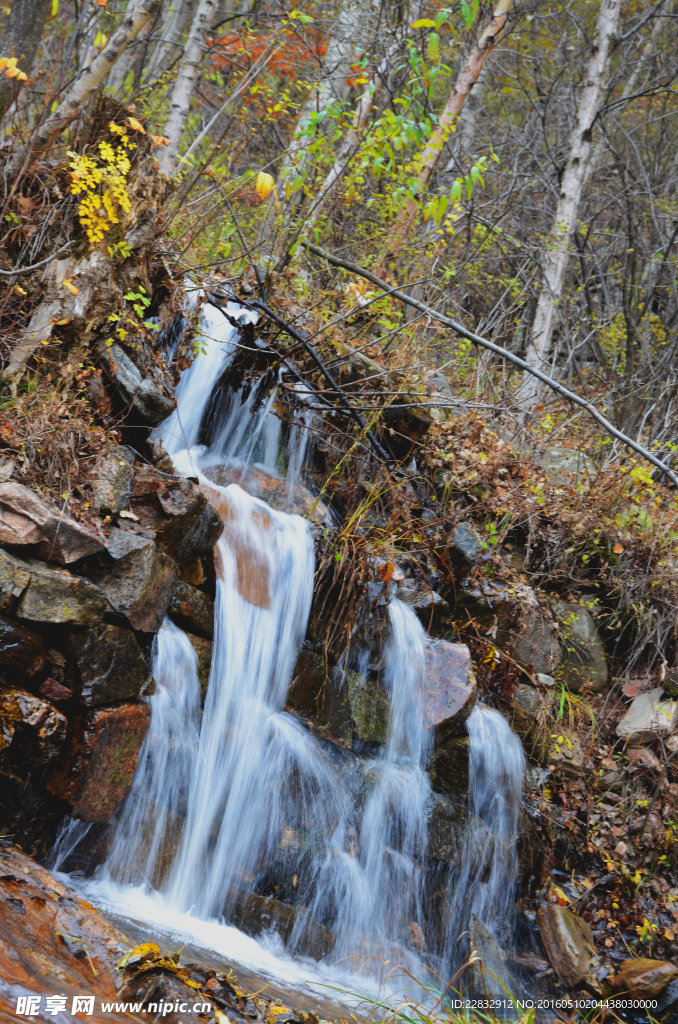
[{"x1": 55, "y1": 306, "x2": 522, "y2": 1003}]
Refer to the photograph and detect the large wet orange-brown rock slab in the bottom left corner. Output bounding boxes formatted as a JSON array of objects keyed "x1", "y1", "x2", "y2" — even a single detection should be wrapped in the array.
[{"x1": 0, "y1": 847, "x2": 139, "y2": 1024}]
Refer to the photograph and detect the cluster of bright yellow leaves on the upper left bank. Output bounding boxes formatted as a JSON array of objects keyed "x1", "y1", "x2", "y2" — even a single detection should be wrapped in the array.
[{"x1": 69, "y1": 123, "x2": 136, "y2": 247}]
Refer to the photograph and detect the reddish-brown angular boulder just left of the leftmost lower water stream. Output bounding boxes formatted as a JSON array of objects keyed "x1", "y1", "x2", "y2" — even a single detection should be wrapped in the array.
[{"x1": 47, "y1": 703, "x2": 151, "y2": 821}]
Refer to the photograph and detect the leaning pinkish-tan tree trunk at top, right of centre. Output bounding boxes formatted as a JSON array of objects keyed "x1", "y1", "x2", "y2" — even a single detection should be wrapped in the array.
[{"x1": 389, "y1": 0, "x2": 513, "y2": 252}]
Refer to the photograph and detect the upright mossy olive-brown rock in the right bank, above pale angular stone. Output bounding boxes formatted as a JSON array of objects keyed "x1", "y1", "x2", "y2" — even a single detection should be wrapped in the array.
[{"x1": 553, "y1": 601, "x2": 607, "y2": 693}]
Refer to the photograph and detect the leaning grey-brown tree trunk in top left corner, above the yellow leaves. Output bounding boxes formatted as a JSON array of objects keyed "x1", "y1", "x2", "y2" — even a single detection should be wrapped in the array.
[{"x1": 6, "y1": 0, "x2": 158, "y2": 177}]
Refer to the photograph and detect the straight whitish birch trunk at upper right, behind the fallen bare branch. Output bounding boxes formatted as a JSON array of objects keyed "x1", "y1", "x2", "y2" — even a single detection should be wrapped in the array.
[{"x1": 518, "y1": 0, "x2": 622, "y2": 415}]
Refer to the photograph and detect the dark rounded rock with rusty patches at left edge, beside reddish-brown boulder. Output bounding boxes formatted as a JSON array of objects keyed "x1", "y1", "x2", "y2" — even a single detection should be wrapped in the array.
[{"x1": 0, "y1": 689, "x2": 67, "y2": 764}]
